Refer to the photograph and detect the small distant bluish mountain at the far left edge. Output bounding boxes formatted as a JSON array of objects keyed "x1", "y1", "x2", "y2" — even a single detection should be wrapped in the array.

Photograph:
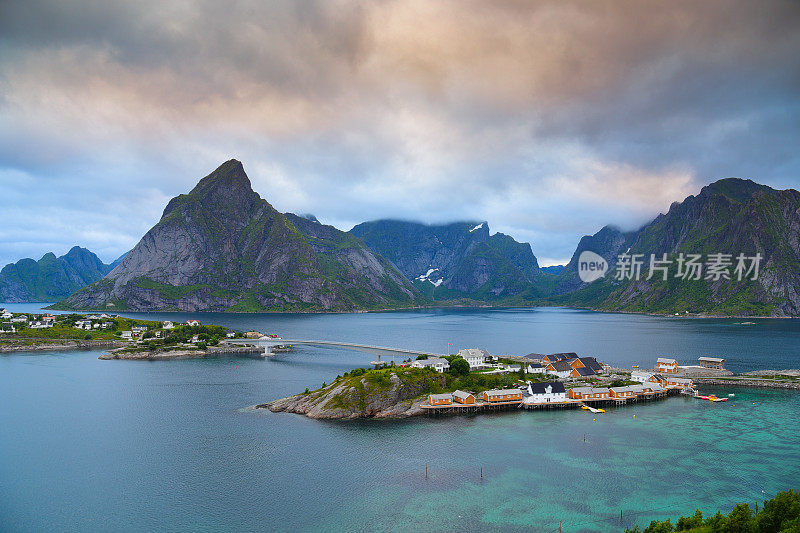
[{"x1": 0, "y1": 246, "x2": 114, "y2": 303}]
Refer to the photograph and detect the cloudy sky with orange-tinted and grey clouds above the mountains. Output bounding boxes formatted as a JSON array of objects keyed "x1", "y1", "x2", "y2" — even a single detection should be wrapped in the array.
[{"x1": 0, "y1": 0, "x2": 800, "y2": 265}]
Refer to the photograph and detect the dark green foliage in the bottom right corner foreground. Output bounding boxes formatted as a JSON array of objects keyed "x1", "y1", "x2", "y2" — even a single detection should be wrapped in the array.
[{"x1": 625, "y1": 490, "x2": 800, "y2": 533}]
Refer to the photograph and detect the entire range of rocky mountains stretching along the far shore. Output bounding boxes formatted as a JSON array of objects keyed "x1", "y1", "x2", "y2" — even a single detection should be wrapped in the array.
[{"x1": 0, "y1": 160, "x2": 800, "y2": 316}]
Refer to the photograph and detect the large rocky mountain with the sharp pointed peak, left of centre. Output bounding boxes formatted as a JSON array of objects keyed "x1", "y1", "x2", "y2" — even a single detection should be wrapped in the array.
[{"x1": 55, "y1": 160, "x2": 424, "y2": 311}]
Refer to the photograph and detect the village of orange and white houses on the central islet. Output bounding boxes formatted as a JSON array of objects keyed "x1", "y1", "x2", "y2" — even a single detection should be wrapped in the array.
[{"x1": 422, "y1": 348, "x2": 725, "y2": 414}]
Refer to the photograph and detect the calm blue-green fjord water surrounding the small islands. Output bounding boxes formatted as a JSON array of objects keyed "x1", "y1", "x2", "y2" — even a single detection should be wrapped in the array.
[{"x1": 0, "y1": 306, "x2": 800, "y2": 531}]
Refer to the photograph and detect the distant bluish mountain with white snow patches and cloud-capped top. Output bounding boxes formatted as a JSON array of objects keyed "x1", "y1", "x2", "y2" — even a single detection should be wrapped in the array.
[{"x1": 350, "y1": 220, "x2": 542, "y2": 301}]
